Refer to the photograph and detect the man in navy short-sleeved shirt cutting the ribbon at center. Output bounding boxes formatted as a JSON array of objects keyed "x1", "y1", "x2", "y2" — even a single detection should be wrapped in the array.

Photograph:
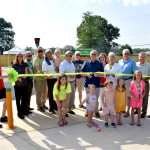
[{"x1": 81, "y1": 50, "x2": 104, "y2": 118}]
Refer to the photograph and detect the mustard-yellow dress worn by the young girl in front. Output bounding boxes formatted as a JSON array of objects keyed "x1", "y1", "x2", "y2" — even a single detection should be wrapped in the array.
[{"x1": 115, "y1": 88, "x2": 126, "y2": 112}]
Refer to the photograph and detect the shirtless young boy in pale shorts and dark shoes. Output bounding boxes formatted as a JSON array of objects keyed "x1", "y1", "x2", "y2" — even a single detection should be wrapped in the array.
[{"x1": 102, "y1": 80, "x2": 116, "y2": 128}]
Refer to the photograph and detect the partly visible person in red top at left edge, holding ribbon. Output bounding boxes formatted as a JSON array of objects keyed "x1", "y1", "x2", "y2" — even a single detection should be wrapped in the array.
[{"x1": 0, "y1": 65, "x2": 12, "y2": 128}]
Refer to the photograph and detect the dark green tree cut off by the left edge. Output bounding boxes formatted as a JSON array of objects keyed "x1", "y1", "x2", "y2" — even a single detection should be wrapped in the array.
[{"x1": 0, "y1": 18, "x2": 15, "y2": 54}]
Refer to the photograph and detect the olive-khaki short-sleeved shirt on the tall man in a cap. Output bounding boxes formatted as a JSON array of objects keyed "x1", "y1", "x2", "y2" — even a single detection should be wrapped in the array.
[{"x1": 33, "y1": 56, "x2": 45, "y2": 80}]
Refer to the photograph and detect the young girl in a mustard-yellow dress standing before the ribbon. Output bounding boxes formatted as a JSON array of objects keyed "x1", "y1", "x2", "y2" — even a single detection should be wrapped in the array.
[{"x1": 115, "y1": 77, "x2": 127, "y2": 125}]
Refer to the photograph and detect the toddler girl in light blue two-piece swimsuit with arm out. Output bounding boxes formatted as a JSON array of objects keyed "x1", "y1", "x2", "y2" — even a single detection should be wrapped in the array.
[{"x1": 80, "y1": 84, "x2": 97, "y2": 127}]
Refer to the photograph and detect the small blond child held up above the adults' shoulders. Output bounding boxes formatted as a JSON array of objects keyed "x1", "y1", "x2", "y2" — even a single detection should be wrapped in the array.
[{"x1": 54, "y1": 48, "x2": 62, "y2": 72}]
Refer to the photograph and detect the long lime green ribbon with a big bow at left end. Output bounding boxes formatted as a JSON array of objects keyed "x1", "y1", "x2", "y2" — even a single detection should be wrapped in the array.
[{"x1": 6, "y1": 68, "x2": 150, "y2": 86}]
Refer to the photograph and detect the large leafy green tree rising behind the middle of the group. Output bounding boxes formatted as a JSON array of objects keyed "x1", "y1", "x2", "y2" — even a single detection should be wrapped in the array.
[{"x1": 77, "y1": 12, "x2": 120, "y2": 53}]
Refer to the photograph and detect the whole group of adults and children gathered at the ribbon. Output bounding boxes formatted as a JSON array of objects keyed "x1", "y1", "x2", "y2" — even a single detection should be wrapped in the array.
[{"x1": 0, "y1": 47, "x2": 150, "y2": 127}]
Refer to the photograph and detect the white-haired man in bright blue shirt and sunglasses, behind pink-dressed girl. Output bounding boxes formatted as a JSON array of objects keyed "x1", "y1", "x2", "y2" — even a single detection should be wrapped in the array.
[{"x1": 118, "y1": 49, "x2": 137, "y2": 117}]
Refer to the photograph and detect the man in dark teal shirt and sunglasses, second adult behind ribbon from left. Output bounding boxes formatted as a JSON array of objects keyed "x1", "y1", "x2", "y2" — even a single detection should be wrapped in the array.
[{"x1": 25, "y1": 51, "x2": 34, "y2": 110}]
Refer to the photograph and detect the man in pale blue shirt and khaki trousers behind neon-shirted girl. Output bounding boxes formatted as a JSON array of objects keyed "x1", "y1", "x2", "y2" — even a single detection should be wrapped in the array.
[{"x1": 59, "y1": 51, "x2": 75, "y2": 116}]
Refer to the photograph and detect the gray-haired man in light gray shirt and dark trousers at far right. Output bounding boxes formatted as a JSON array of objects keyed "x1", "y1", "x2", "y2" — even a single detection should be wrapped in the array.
[{"x1": 136, "y1": 52, "x2": 150, "y2": 118}]
